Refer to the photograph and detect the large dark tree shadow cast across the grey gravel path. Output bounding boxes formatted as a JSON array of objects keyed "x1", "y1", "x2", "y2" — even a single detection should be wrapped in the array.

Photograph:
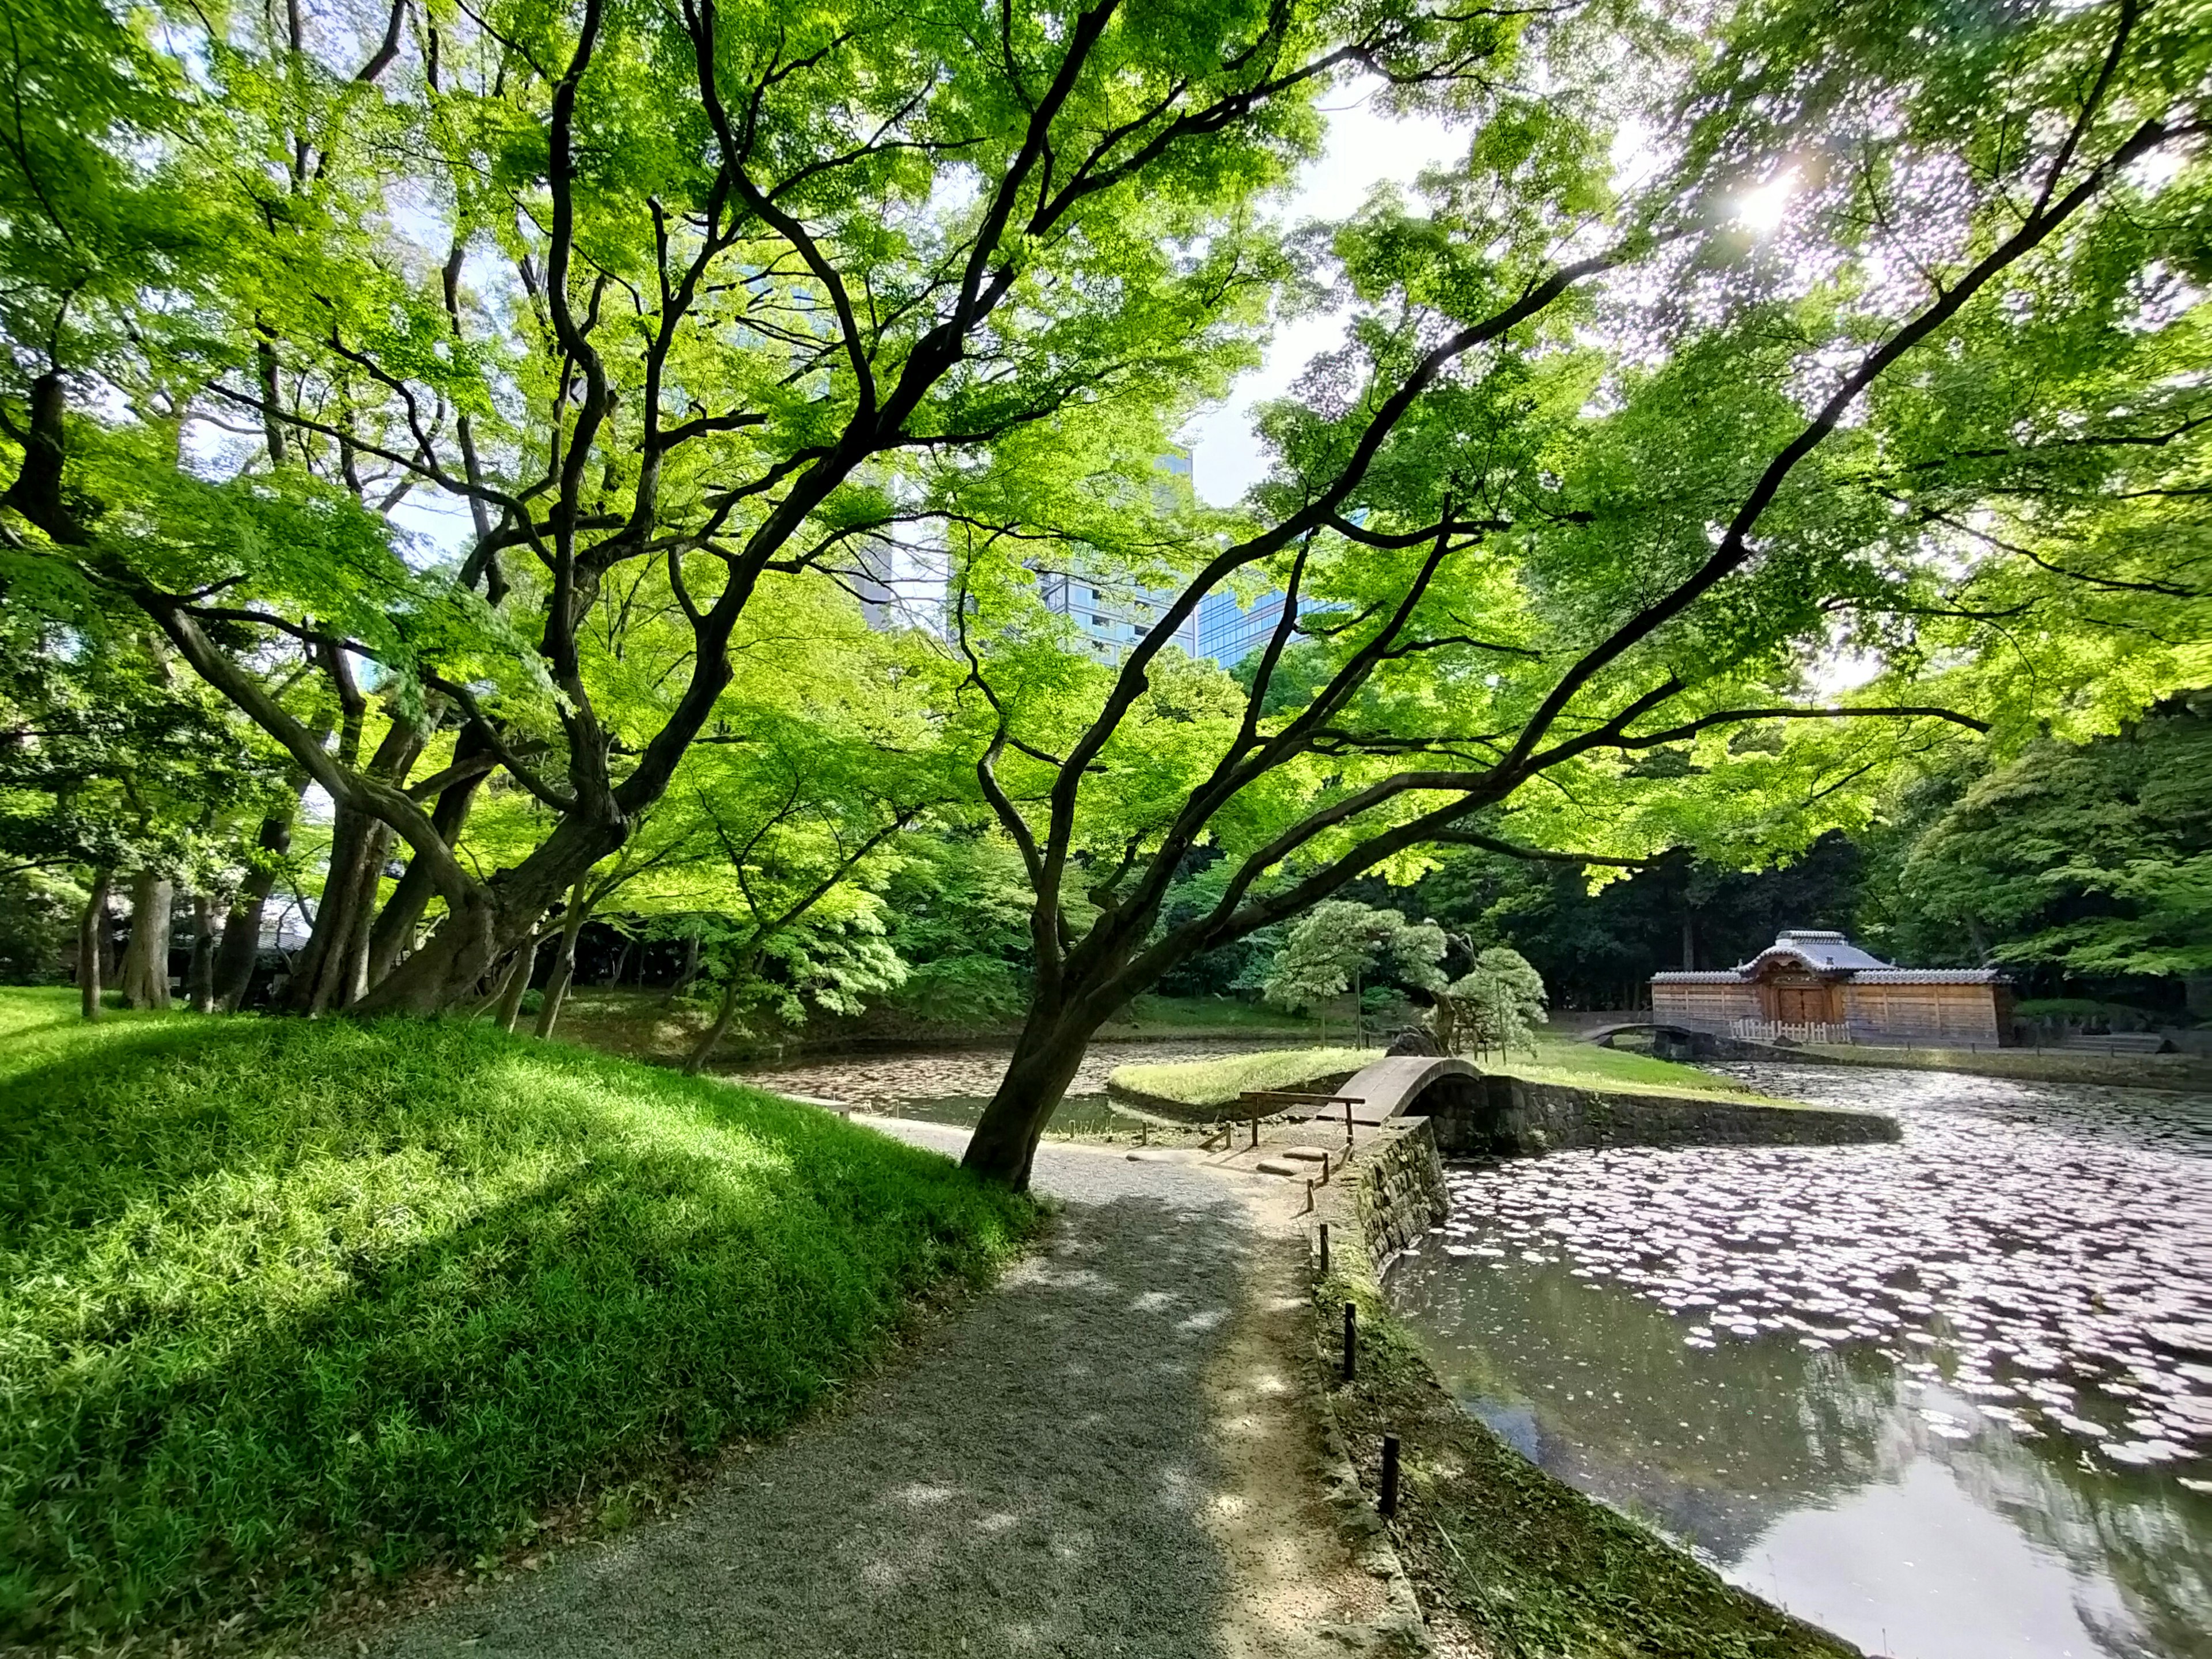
[{"x1": 354, "y1": 1195, "x2": 1250, "y2": 1659}]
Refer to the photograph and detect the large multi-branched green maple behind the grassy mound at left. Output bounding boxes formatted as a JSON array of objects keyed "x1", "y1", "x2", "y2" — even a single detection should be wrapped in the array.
[{"x1": 0, "y1": 0, "x2": 1524, "y2": 1011}]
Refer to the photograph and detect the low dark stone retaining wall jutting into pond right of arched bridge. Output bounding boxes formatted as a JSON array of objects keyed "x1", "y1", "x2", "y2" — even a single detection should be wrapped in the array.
[{"x1": 1418, "y1": 1073, "x2": 1898, "y2": 1157}]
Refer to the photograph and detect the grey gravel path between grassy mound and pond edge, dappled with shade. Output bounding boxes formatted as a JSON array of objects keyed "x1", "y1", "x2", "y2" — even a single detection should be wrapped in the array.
[{"x1": 340, "y1": 1124, "x2": 1380, "y2": 1659}]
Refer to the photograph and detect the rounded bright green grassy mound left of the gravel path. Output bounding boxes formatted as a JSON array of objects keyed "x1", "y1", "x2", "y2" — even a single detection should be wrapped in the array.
[{"x1": 0, "y1": 988, "x2": 1033, "y2": 1646}]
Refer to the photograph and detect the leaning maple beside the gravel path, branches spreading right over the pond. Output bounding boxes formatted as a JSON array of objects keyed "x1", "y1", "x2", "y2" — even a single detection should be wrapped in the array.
[{"x1": 947, "y1": 0, "x2": 2207, "y2": 1183}]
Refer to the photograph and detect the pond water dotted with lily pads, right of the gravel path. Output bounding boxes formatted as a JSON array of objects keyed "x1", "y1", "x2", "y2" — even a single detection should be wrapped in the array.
[{"x1": 1389, "y1": 1066, "x2": 2212, "y2": 1659}]
